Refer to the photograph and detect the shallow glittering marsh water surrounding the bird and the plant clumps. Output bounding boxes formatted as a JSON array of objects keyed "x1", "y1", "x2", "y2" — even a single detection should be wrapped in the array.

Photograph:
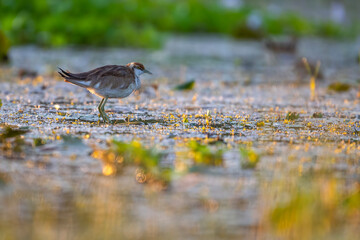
[{"x1": 0, "y1": 36, "x2": 360, "y2": 239}]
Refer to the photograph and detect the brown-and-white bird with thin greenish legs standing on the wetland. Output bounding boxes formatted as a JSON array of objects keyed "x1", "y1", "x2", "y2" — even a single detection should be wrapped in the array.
[{"x1": 58, "y1": 62, "x2": 152, "y2": 123}]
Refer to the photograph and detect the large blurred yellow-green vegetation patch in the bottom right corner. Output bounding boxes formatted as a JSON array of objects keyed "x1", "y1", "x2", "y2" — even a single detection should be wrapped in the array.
[{"x1": 269, "y1": 174, "x2": 360, "y2": 239}]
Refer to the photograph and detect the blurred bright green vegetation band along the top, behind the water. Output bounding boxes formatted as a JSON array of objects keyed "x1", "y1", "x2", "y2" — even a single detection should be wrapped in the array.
[{"x1": 0, "y1": 0, "x2": 359, "y2": 53}]
